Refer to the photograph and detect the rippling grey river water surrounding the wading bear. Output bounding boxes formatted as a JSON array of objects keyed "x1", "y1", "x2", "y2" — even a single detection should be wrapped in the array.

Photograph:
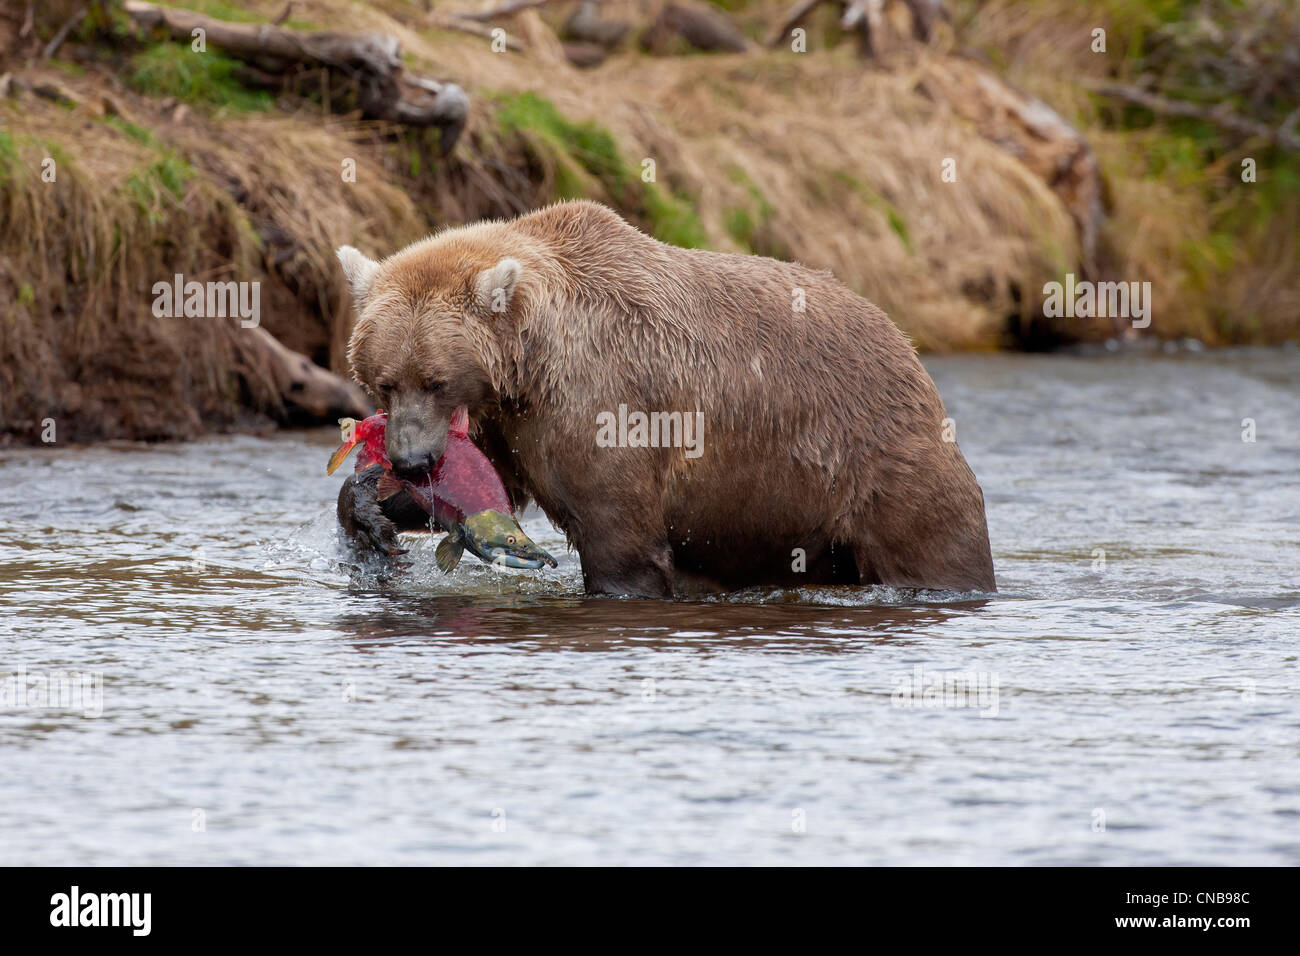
[{"x1": 0, "y1": 349, "x2": 1300, "y2": 865}]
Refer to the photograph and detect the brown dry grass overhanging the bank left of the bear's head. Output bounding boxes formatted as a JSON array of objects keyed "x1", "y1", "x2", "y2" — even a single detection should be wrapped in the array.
[{"x1": 0, "y1": 78, "x2": 426, "y2": 441}]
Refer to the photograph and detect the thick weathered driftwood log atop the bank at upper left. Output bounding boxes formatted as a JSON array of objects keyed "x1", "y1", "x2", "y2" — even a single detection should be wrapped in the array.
[{"x1": 124, "y1": 0, "x2": 469, "y2": 153}]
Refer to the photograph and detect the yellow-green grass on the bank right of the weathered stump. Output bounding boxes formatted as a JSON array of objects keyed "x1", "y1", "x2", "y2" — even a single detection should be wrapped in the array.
[{"x1": 954, "y1": 0, "x2": 1300, "y2": 345}]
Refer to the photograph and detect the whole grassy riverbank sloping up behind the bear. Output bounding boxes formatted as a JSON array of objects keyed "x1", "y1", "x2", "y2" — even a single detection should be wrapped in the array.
[{"x1": 0, "y1": 0, "x2": 1300, "y2": 442}]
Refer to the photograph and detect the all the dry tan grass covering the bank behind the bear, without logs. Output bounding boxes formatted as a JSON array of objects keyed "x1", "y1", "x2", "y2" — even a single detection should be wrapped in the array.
[{"x1": 0, "y1": 0, "x2": 1300, "y2": 440}]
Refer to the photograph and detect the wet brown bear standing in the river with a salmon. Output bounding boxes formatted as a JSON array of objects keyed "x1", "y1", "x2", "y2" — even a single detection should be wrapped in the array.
[{"x1": 338, "y1": 202, "x2": 996, "y2": 597}]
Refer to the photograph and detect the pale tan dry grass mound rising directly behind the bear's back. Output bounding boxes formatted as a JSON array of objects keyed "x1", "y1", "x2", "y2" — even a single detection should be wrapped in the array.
[{"x1": 343, "y1": 3, "x2": 1076, "y2": 350}]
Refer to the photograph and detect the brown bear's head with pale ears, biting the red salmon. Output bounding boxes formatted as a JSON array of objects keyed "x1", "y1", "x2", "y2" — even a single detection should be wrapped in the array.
[{"x1": 338, "y1": 241, "x2": 523, "y2": 479}]
